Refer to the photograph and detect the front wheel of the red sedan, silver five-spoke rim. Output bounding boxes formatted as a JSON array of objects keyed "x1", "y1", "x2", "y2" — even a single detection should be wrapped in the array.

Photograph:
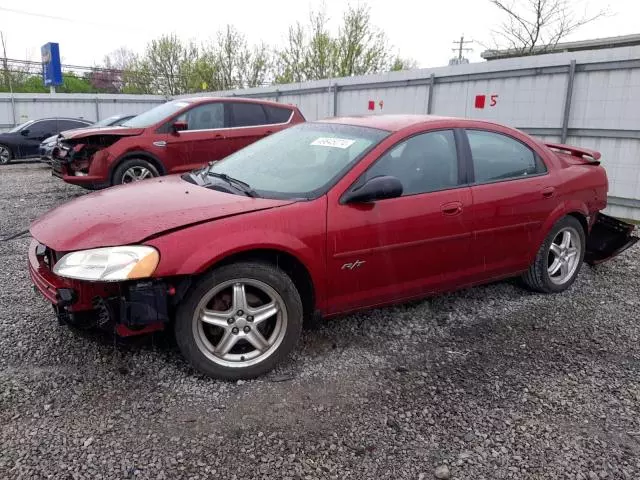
[{"x1": 175, "y1": 262, "x2": 302, "y2": 380}]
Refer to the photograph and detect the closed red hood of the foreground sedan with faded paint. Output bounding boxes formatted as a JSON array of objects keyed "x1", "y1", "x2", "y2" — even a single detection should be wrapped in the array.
[{"x1": 30, "y1": 175, "x2": 293, "y2": 252}]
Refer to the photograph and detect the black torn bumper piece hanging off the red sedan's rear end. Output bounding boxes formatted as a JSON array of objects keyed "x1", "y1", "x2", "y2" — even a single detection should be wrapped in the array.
[{"x1": 584, "y1": 213, "x2": 639, "y2": 265}]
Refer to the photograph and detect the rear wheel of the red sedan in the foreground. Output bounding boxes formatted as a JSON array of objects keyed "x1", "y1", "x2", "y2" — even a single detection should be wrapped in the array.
[{"x1": 522, "y1": 216, "x2": 586, "y2": 293}]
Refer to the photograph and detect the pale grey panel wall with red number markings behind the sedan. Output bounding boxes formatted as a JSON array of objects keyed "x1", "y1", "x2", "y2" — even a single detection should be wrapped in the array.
[{"x1": 180, "y1": 47, "x2": 640, "y2": 220}]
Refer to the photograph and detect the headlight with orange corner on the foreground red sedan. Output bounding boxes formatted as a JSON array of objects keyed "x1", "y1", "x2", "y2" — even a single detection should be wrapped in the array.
[{"x1": 53, "y1": 245, "x2": 160, "y2": 282}]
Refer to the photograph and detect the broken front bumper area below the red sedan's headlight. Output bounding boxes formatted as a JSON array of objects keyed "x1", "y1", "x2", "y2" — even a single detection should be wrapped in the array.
[{"x1": 29, "y1": 240, "x2": 175, "y2": 336}]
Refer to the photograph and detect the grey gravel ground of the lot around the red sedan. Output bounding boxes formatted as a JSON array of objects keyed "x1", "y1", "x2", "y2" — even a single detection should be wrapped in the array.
[{"x1": 0, "y1": 163, "x2": 640, "y2": 480}]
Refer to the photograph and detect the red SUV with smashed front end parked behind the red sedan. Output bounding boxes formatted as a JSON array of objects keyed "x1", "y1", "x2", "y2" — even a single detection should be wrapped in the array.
[{"x1": 52, "y1": 97, "x2": 304, "y2": 189}]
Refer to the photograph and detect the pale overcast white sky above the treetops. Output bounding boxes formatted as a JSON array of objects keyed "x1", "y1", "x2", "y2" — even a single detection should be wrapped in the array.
[{"x1": 0, "y1": 0, "x2": 640, "y2": 68}]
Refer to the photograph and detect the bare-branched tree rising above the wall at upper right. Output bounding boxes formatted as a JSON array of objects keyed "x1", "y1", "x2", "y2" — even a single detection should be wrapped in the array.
[{"x1": 489, "y1": 0, "x2": 607, "y2": 55}]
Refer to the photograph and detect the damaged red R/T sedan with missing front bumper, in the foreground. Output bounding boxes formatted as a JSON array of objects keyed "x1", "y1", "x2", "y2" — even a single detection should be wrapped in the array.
[{"x1": 29, "y1": 116, "x2": 637, "y2": 379}]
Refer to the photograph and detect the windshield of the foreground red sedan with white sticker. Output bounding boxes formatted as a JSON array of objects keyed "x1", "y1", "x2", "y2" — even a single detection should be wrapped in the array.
[{"x1": 208, "y1": 123, "x2": 389, "y2": 198}]
